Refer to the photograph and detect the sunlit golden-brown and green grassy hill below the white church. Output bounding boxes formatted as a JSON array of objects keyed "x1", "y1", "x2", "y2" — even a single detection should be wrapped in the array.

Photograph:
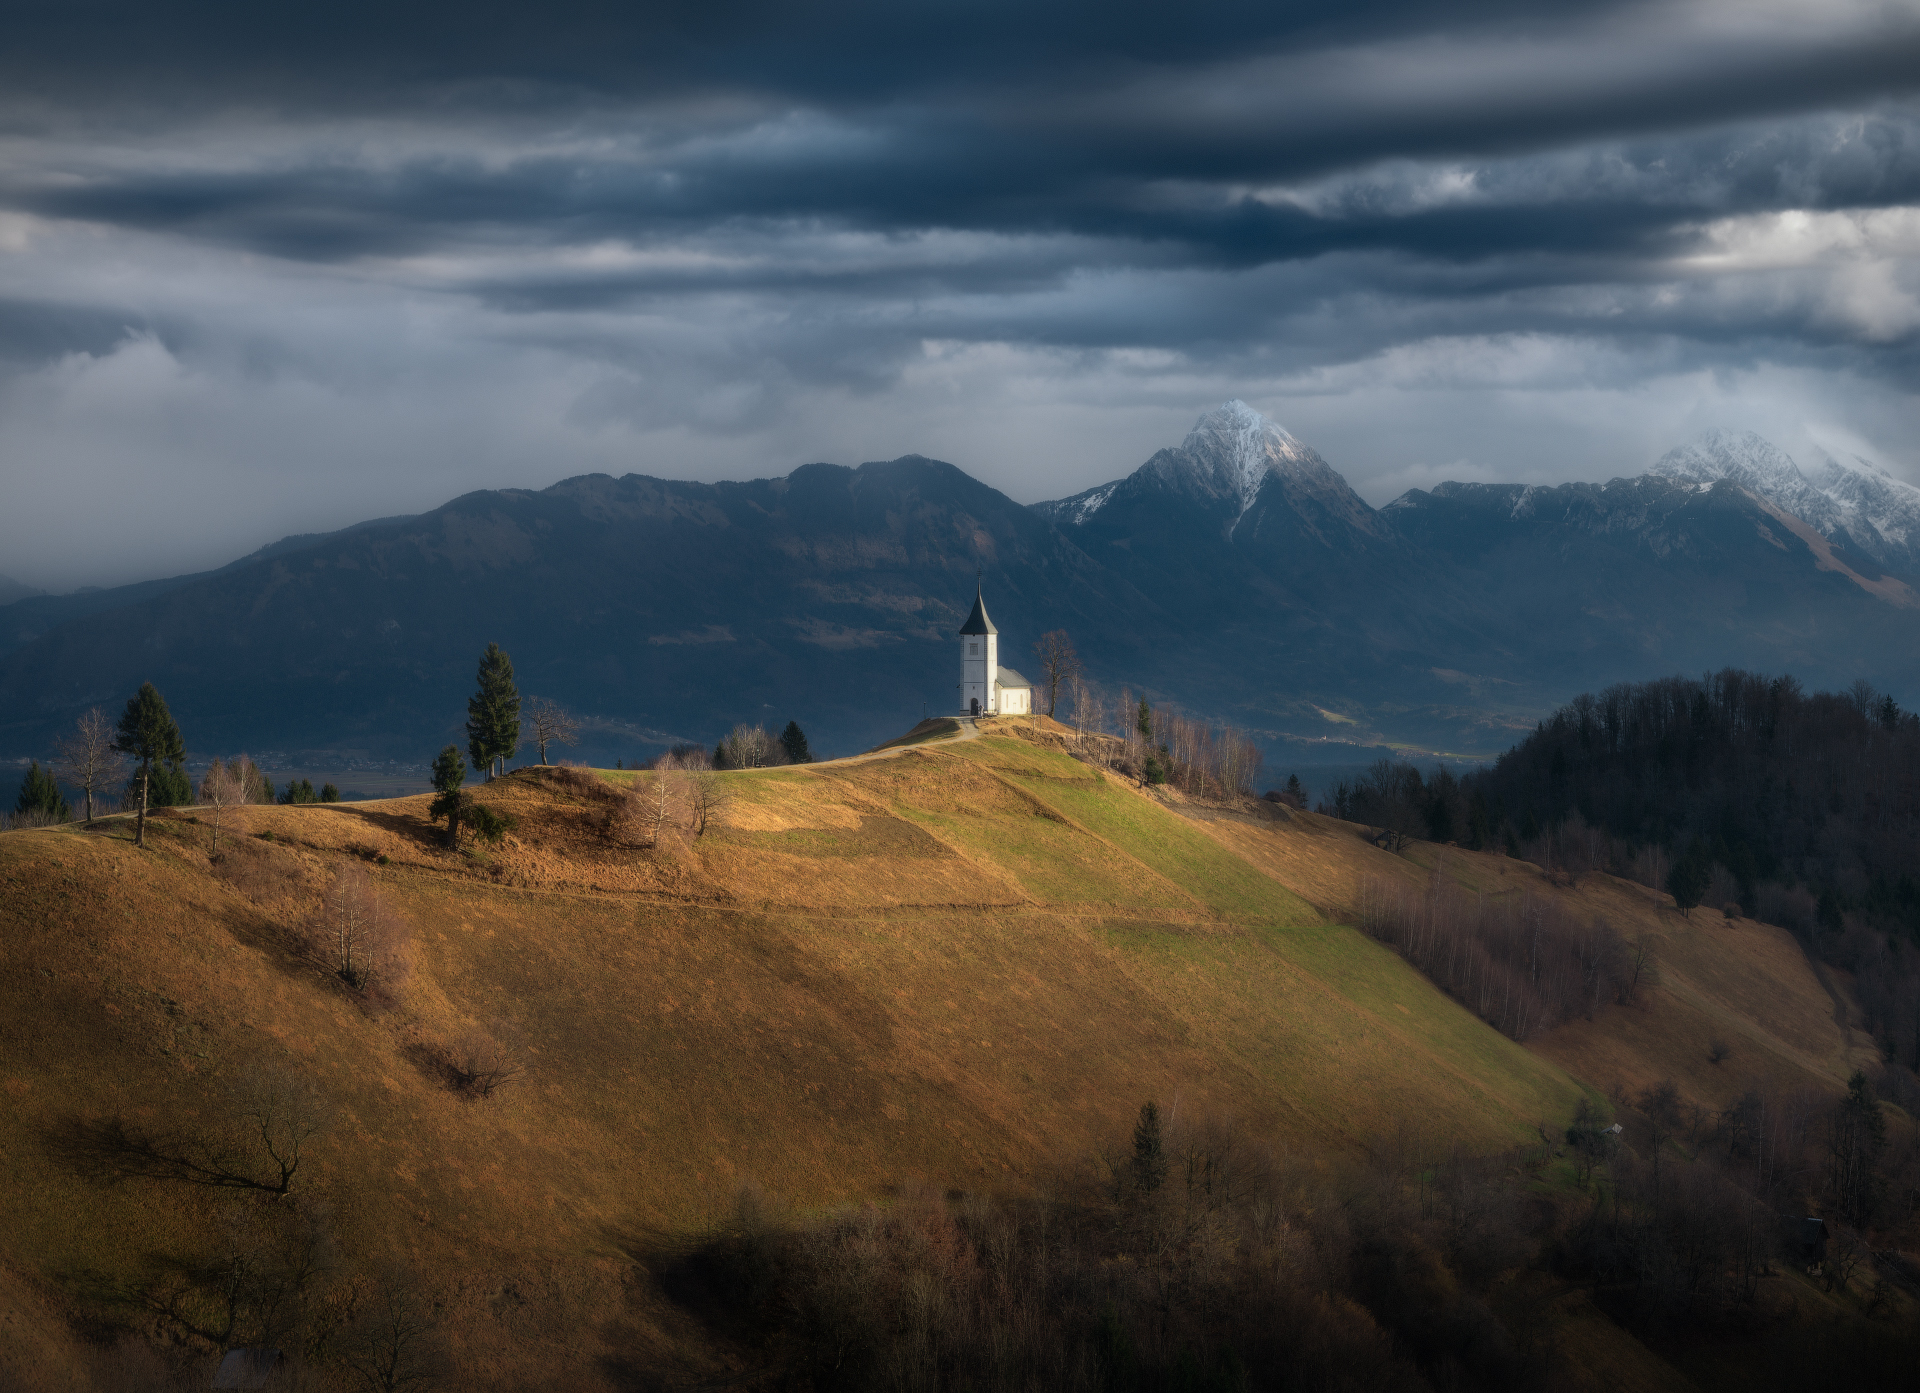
[{"x1": 0, "y1": 723, "x2": 1859, "y2": 1389}]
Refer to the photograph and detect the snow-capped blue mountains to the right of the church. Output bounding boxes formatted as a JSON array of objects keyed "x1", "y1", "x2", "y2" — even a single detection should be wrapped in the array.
[{"x1": 1035, "y1": 401, "x2": 1920, "y2": 750}]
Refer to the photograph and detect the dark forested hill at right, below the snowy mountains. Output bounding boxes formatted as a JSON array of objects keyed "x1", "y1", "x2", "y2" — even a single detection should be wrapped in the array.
[{"x1": 1455, "y1": 668, "x2": 1920, "y2": 1071}]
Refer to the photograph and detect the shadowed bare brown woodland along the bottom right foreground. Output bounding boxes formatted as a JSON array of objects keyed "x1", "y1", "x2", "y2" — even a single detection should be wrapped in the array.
[{"x1": 672, "y1": 1084, "x2": 1920, "y2": 1393}]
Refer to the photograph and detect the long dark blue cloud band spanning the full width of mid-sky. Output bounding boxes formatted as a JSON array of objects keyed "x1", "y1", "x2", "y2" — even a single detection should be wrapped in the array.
[{"x1": 15, "y1": 111, "x2": 1920, "y2": 289}]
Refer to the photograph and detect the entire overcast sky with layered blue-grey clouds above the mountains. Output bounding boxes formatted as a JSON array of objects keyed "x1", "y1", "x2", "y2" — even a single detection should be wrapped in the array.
[{"x1": 0, "y1": 0, "x2": 1920, "y2": 589}]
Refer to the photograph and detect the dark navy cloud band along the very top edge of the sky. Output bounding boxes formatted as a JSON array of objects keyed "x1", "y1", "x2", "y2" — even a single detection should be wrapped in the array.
[{"x1": 0, "y1": 0, "x2": 1622, "y2": 111}]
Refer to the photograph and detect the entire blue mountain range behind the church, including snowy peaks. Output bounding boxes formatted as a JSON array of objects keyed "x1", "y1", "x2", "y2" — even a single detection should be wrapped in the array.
[{"x1": 0, "y1": 401, "x2": 1920, "y2": 764}]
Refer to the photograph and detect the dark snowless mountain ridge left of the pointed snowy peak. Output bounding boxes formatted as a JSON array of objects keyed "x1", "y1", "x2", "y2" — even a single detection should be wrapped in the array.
[{"x1": 0, "y1": 457, "x2": 1156, "y2": 758}]
